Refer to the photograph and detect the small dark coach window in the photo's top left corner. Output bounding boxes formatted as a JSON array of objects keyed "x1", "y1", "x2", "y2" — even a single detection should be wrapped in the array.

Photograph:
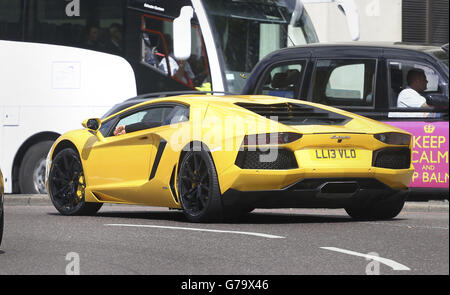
[{"x1": 0, "y1": 0, "x2": 22, "y2": 41}]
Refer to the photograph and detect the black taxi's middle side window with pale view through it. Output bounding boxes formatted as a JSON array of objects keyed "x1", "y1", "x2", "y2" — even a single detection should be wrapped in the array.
[{"x1": 312, "y1": 59, "x2": 376, "y2": 106}]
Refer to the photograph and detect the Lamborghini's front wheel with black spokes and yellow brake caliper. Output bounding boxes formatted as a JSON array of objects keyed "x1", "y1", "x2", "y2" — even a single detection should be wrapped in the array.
[{"x1": 48, "y1": 148, "x2": 103, "y2": 215}]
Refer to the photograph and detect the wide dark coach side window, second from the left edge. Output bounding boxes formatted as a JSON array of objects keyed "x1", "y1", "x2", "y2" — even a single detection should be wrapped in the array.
[{"x1": 30, "y1": 0, "x2": 123, "y2": 55}]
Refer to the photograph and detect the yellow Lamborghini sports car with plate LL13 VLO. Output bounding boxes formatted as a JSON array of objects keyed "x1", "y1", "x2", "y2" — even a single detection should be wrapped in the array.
[{"x1": 47, "y1": 94, "x2": 414, "y2": 222}]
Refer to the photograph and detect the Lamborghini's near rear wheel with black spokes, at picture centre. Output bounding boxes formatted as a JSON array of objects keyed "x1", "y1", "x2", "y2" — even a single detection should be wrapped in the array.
[{"x1": 177, "y1": 147, "x2": 223, "y2": 222}]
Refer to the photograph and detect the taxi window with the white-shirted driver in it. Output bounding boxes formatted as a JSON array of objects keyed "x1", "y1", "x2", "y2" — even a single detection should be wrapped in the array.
[{"x1": 388, "y1": 60, "x2": 448, "y2": 117}]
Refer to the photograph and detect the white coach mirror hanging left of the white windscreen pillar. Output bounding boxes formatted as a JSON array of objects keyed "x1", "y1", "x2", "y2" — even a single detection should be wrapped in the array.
[{"x1": 173, "y1": 6, "x2": 194, "y2": 61}]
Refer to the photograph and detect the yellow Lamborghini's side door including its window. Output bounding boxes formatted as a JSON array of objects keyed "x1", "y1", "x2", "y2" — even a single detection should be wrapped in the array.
[{"x1": 85, "y1": 105, "x2": 173, "y2": 202}]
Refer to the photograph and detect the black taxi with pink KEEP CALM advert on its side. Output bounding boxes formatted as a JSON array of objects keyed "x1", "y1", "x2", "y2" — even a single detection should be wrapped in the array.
[{"x1": 243, "y1": 42, "x2": 449, "y2": 198}]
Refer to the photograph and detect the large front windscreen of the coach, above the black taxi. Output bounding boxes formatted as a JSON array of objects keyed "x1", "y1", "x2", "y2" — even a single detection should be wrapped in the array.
[{"x1": 204, "y1": 0, "x2": 318, "y2": 93}]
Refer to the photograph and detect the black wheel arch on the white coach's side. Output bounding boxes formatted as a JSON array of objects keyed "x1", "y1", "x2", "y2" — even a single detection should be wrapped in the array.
[{"x1": 12, "y1": 131, "x2": 60, "y2": 193}]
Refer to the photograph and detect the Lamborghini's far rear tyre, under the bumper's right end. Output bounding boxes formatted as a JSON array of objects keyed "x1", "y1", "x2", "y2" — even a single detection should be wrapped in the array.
[{"x1": 345, "y1": 193, "x2": 406, "y2": 220}]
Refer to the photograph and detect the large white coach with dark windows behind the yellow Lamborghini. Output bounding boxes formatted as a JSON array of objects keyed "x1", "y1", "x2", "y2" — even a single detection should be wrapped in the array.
[{"x1": 0, "y1": 0, "x2": 354, "y2": 193}]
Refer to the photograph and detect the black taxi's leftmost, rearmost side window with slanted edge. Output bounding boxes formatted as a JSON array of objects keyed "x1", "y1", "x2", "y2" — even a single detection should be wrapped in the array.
[{"x1": 256, "y1": 61, "x2": 305, "y2": 98}]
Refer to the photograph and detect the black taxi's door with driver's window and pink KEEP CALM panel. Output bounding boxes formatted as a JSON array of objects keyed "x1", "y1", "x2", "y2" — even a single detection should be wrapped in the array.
[{"x1": 383, "y1": 54, "x2": 449, "y2": 192}]
